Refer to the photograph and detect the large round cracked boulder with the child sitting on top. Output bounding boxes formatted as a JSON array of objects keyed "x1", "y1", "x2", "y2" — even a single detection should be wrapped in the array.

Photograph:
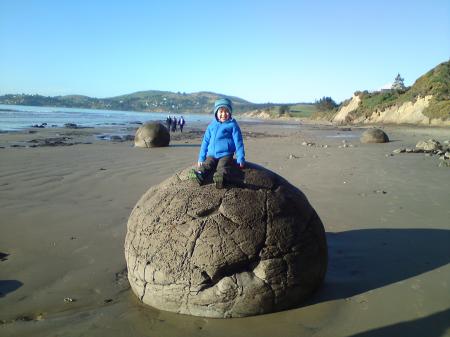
[{"x1": 125, "y1": 163, "x2": 328, "y2": 318}]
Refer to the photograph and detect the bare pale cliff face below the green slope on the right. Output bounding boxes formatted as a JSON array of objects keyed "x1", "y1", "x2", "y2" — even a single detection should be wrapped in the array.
[{"x1": 332, "y1": 95, "x2": 450, "y2": 126}]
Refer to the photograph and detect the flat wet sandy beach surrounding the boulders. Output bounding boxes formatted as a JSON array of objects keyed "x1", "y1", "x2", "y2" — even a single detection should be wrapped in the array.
[{"x1": 0, "y1": 122, "x2": 450, "y2": 337}]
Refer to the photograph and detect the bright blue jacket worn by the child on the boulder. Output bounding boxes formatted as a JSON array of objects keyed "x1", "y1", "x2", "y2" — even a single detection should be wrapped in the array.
[{"x1": 198, "y1": 116, "x2": 245, "y2": 164}]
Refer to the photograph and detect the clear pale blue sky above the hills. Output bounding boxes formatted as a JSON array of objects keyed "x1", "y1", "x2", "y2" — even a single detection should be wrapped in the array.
[{"x1": 0, "y1": 0, "x2": 450, "y2": 103}]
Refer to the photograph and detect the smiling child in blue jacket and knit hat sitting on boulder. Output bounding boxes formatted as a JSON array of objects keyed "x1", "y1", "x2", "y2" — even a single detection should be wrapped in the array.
[{"x1": 190, "y1": 98, "x2": 245, "y2": 188}]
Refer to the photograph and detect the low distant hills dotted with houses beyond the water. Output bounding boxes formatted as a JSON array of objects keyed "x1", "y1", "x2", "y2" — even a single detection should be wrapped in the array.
[{"x1": 0, "y1": 90, "x2": 272, "y2": 114}]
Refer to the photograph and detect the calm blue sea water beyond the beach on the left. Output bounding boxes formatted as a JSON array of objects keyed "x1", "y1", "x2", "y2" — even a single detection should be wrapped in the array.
[{"x1": 0, "y1": 104, "x2": 212, "y2": 131}]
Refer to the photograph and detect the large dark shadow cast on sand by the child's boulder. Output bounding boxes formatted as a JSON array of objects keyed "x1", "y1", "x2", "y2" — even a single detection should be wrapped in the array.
[{"x1": 312, "y1": 229, "x2": 450, "y2": 303}]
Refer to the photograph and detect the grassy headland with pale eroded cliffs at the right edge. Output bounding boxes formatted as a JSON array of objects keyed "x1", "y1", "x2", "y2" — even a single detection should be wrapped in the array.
[{"x1": 328, "y1": 61, "x2": 450, "y2": 125}]
